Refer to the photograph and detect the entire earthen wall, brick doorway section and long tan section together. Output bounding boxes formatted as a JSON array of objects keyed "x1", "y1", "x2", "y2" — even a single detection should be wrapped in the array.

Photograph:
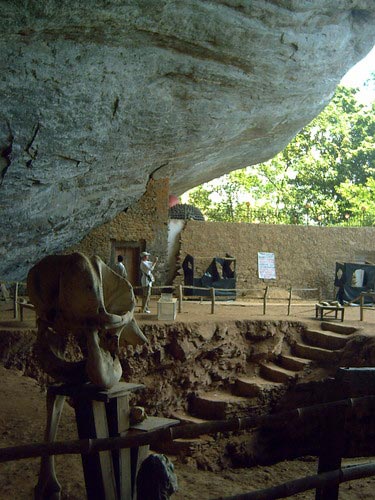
[{"x1": 69, "y1": 184, "x2": 375, "y2": 298}]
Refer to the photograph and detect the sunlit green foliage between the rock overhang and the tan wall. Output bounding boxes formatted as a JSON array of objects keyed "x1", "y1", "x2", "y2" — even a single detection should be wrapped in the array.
[{"x1": 185, "y1": 86, "x2": 375, "y2": 225}]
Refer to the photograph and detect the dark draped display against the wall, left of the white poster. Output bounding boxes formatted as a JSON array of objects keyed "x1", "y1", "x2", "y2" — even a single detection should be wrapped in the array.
[{"x1": 182, "y1": 255, "x2": 236, "y2": 298}]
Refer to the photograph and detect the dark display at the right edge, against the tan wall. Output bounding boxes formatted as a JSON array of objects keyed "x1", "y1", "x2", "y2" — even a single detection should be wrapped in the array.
[{"x1": 335, "y1": 262, "x2": 375, "y2": 304}]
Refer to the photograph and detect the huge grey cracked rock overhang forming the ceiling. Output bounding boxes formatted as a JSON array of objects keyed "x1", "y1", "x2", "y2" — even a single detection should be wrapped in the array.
[{"x1": 0, "y1": 0, "x2": 375, "y2": 280}]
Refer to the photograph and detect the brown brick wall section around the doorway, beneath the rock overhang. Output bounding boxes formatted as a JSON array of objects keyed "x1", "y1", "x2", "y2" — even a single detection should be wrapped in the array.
[{"x1": 67, "y1": 179, "x2": 169, "y2": 285}]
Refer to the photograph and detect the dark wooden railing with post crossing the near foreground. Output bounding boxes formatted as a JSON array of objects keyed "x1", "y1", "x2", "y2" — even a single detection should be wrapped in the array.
[{"x1": 0, "y1": 396, "x2": 375, "y2": 500}]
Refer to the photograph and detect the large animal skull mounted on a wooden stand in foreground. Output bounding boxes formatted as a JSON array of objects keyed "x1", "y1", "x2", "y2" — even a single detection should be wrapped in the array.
[{"x1": 27, "y1": 253, "x2": 147, "y2": 389}]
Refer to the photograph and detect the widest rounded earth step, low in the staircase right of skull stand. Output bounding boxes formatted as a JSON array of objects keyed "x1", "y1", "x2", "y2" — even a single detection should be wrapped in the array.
[{"x1": 189, "y1": 391, "x2": 259, "y2": 420}]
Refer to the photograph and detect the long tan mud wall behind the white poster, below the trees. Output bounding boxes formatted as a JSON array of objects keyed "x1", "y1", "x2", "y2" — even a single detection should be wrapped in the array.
[{"x1": 175, "y1": 221, "x2": 375, "y2": 298}]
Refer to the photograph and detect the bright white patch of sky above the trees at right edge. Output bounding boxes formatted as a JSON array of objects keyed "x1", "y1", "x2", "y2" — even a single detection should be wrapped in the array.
[{"x1": 340, "y1": 46, "x2": 375, "y2": 104}]
